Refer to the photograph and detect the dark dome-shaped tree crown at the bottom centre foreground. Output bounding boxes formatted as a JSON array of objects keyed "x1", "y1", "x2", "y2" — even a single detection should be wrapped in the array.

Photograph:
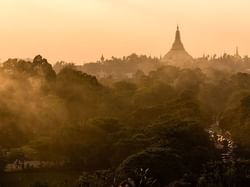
[{"x1": 116, "y1": 148, "x2": 188, "y2": 185}]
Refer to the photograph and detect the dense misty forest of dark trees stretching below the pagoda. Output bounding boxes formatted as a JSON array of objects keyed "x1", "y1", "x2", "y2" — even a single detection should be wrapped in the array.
[{"x1": 0, "y1": 54, "x2": 250, "y2": 187}]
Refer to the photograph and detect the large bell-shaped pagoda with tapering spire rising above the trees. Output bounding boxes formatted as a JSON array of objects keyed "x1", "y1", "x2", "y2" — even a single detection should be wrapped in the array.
[{"x1": 161, "y1": 26, "x2": 193, "y2": 67}]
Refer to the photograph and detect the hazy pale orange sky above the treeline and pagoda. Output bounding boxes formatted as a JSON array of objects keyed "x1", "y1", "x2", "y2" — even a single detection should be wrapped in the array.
[{"x1": 0, "y1": 0, "x2": 250, "y2": 63}]
